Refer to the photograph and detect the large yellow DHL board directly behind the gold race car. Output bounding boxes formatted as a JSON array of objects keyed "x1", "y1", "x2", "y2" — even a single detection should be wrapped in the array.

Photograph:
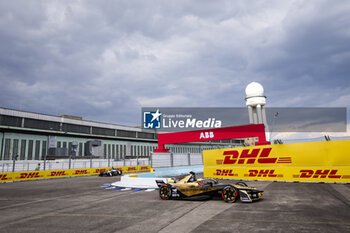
[{"x1": 203, "y1": 140, "x2": 350, "y2": 183}]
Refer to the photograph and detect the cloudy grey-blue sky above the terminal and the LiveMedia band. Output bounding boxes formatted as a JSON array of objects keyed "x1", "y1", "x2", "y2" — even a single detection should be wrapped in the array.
[{"x1": 0, "y1": 0, "x2": 350, "y2": 133}]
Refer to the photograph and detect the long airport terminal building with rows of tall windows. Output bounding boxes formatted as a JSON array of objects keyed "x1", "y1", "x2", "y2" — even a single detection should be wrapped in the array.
[{"x1": 0, "y1": 108, "x2": 242, "y2": 160}]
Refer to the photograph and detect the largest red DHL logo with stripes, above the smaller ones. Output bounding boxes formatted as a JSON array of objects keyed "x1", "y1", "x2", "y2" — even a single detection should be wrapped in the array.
[{"x1": 216, "y1": 148, "x2": 292, "y2": 165}]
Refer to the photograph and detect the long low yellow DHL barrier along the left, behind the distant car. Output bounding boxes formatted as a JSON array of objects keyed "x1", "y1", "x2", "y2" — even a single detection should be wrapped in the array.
[{"x1": 0, "y1": 165, "x2": 151, "y2": 183}]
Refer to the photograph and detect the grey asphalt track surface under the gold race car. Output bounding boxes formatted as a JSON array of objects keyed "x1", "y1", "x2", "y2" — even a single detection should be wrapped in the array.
[{"x1": 0, "y1": 176, "x2": 350, "y2": 233}]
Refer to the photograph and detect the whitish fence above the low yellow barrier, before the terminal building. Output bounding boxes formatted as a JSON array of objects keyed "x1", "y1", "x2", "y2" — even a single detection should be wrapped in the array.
[{"x1": 0, "y1": 158, "x2": 150, "y2": 173}]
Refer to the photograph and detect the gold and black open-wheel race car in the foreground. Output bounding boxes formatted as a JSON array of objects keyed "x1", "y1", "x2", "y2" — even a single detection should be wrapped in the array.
[{"x1": 156, "y1": 172, "x2": 263, "y2": 203}]
